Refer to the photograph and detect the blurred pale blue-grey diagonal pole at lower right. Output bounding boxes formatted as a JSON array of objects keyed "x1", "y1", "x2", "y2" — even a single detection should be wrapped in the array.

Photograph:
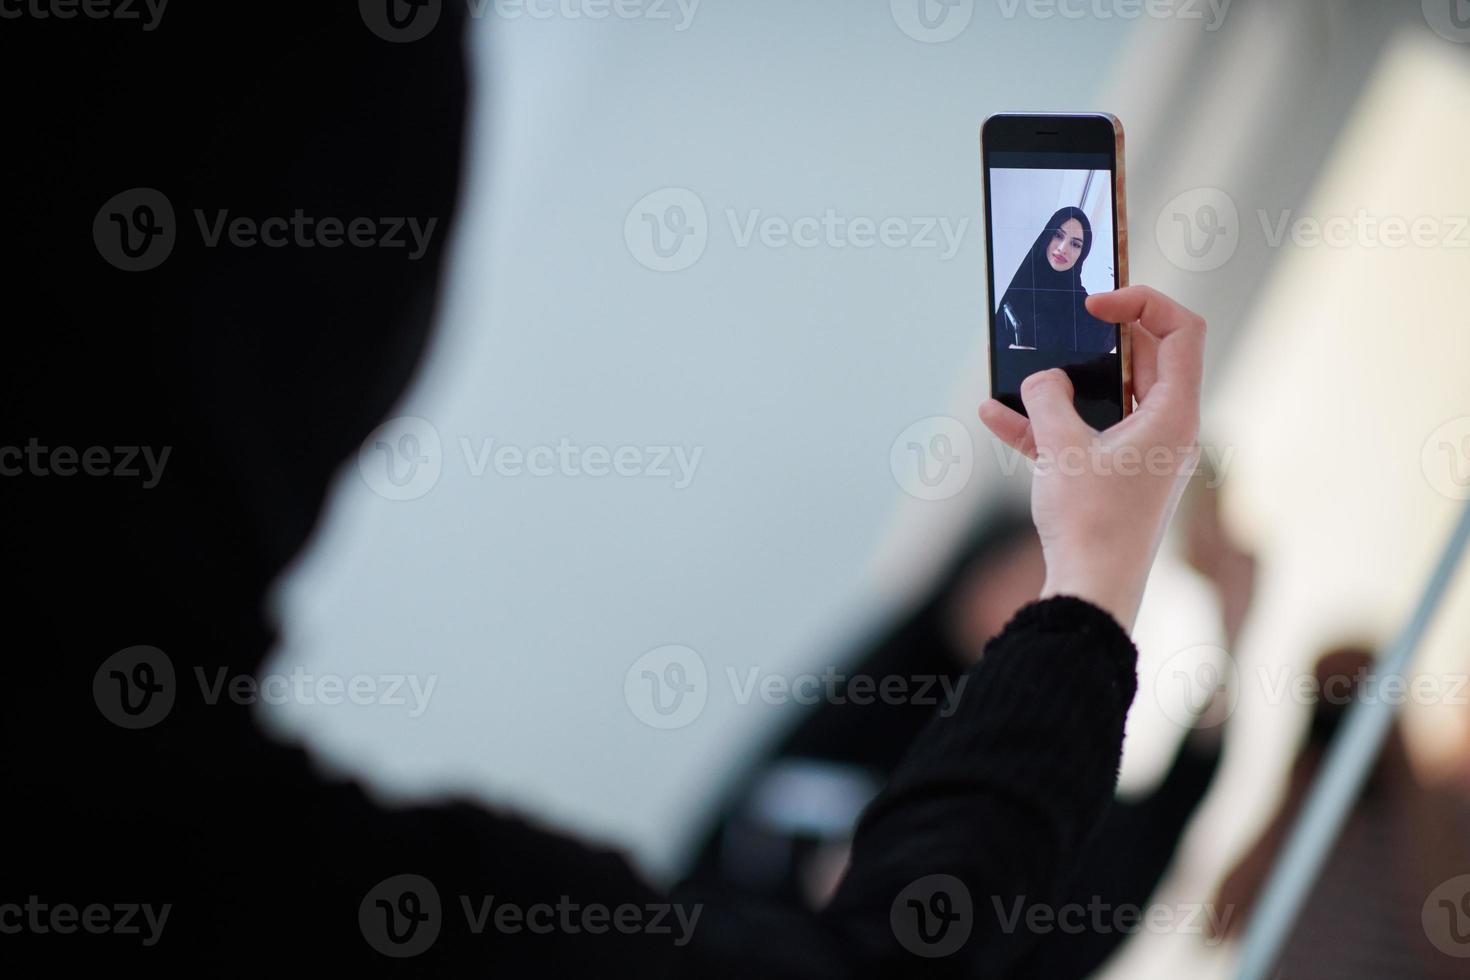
[{"x1": 1236, "y1": 501, "x2": 1470, "y2": 980}]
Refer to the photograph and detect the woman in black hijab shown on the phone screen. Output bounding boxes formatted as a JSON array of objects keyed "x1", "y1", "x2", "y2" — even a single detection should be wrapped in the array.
[{"x1": 995, "y1": 207, "x2": 1117, "y2": 354}]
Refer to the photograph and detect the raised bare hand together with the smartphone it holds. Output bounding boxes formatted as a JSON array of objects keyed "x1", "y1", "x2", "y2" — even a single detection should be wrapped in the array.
[{"x1": 980, "y1": 115, "x2": 1204, "y2": 629}]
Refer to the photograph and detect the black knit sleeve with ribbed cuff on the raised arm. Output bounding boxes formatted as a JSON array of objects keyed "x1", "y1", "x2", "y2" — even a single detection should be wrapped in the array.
[{"x1": 825, "y1": 597, "x2": 1138, "y2": 977}]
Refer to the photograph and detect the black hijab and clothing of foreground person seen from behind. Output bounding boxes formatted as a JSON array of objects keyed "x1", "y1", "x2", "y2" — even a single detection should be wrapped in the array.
[{"x1": 0, "y1": 7, "x2": 1194, "y2": 980}]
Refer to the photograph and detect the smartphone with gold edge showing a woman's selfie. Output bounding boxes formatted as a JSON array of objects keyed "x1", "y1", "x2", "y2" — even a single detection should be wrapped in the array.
[{"x1": 980, "y1": 113, "x2": 1133, "y2": 429}]
